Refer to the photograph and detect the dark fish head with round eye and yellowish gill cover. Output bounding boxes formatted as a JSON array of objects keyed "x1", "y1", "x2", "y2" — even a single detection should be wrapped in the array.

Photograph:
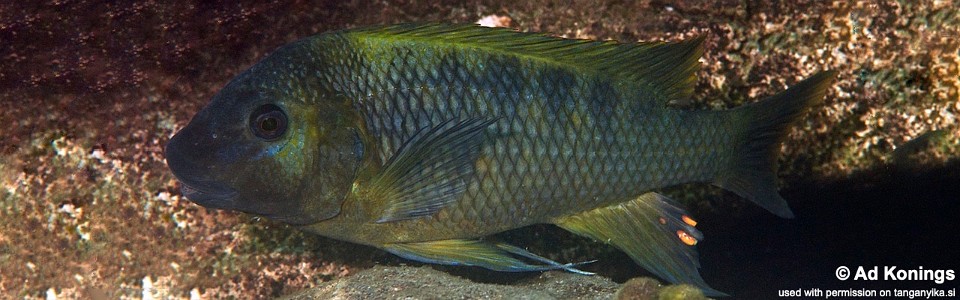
[{"x1": 165, "y1": 56, "x2": 363, "y2": 225}]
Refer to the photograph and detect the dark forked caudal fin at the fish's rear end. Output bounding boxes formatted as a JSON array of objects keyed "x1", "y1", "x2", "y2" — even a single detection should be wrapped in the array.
[{"x1": 713, "y1": 71, "x2": 837, "y2": 218}]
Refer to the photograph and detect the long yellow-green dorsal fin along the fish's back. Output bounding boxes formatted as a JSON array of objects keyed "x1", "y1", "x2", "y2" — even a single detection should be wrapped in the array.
[{"x1": 343, "y1": 23, "x2": 703, "y2": 103}]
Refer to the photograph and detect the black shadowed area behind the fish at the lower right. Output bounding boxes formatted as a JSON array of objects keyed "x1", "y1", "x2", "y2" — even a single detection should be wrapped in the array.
[{"x1": 700, "y1": 160, "x2": 960, "y2": 299}]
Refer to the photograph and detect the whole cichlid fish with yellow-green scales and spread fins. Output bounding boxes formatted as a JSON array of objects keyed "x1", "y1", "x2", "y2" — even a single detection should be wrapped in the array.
[{"x1": 166, "y1": 24, "x2": 834, "y2": 296}]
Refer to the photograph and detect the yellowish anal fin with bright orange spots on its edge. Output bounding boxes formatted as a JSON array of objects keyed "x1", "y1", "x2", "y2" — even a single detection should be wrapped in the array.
[{"x1": 555, "y1": 193, "x2": 725, "y2": 296}]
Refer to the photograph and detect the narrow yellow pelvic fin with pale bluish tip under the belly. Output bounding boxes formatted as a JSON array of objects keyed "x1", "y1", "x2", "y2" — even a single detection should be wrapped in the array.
[{"x1": 383, "y1": 240, "x2": 592, "y2": 275}]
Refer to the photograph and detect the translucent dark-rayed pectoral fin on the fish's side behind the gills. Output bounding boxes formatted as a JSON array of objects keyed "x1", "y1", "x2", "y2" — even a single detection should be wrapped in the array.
[{"x1": 371, "y1": 118, "x2": 493, "y2": 223}]
